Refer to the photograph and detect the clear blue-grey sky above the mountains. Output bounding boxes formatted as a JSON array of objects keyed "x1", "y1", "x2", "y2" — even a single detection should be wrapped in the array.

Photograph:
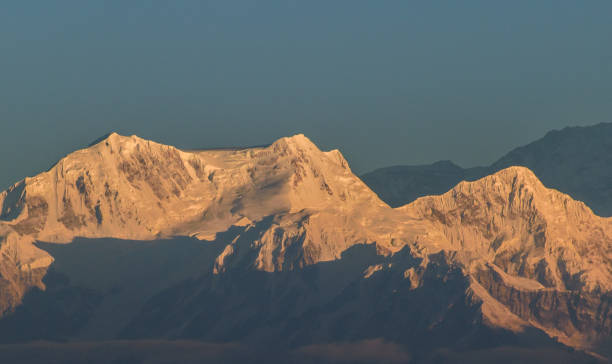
[{"x1": 0, "y1": 0, "x2": 612, "y2": 188}]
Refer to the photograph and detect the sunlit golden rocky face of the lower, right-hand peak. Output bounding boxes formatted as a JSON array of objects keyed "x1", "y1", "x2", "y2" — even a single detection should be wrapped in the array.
[{"x1": 400, "y1": 167, "x2": 612, "y2": 346}]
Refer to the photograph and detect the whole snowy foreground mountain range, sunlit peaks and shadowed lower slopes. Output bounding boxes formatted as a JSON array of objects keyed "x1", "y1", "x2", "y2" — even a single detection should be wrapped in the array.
[{"x1": 0, "y1": 133, "x2": 612, "y2": 362}]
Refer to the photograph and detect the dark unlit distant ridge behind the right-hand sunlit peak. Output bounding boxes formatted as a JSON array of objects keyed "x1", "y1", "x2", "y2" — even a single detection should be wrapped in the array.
[{"x1": 362, "y1": 123, "x2": 612, "y2": 216}]
